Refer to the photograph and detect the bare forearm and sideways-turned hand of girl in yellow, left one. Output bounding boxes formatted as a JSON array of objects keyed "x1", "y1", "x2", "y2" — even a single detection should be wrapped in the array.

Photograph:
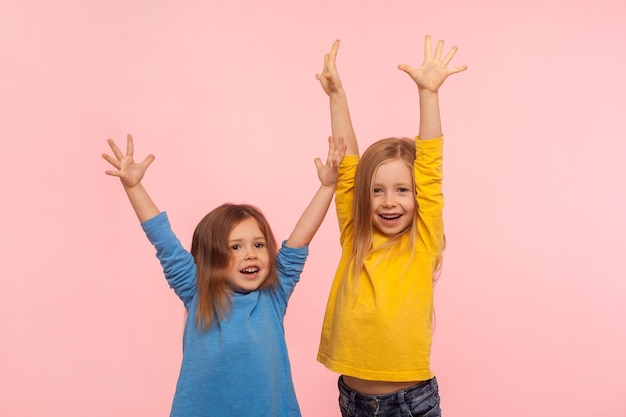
[{"x1": 315, "y1": 40, "x2": 359, "y2": 155}]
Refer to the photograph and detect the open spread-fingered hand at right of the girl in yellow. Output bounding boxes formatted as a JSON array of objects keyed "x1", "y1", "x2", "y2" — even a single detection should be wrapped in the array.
[{"x1": 398, "y1": 35, "x2": 467, "y2": 93}]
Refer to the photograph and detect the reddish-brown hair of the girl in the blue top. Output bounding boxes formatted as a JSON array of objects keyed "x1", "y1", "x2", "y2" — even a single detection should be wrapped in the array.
[{"x1": 191, "y1": 204, "x2": 278, "y2": 331}]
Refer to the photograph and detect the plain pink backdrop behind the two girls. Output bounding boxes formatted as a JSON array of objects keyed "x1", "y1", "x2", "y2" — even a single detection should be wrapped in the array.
[{"x1": 0, "y1": 0, "x2": 626, "y2": 417}]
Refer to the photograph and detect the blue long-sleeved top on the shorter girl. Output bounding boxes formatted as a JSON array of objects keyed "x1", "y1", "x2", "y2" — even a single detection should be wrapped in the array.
[{"x1": 142, "y1": 213, "x2": 308, "y2": 417}]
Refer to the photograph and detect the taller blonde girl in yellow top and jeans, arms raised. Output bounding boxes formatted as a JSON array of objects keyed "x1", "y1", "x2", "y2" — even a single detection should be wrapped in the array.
[{"x1": 317, "y1": 36, "x2": 467, "y2": 417}]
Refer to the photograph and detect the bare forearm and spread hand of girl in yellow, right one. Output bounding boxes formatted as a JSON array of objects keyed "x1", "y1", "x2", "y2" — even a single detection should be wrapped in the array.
[{"x1": 398, "y1": 35, "x2": 467, "y2": 139}]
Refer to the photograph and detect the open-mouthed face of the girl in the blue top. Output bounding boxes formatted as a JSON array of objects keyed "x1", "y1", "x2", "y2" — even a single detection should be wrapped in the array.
[{"x1": 226, "y1": 217, "x2": 270, "y2": 293}]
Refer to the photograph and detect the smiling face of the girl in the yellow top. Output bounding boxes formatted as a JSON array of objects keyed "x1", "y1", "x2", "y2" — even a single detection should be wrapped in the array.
[{"x1": 371, "y1": 159, "x2": 415, "y2": 236}]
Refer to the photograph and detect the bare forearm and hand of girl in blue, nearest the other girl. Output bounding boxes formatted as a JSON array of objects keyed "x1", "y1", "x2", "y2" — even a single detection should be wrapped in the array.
[{"x1": 286, "y1": 136, "x2": 346, "y2": 248}]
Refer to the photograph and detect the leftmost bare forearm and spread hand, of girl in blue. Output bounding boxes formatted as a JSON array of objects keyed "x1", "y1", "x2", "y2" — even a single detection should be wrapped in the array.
[{"x1": 102, "y1": 134, "x2": 160, "y2": 222}]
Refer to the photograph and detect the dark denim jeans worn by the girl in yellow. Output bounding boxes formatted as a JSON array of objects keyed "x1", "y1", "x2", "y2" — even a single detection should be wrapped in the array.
[{"x1": 338, "y1": 376, "x2": 441, "y2": 417}]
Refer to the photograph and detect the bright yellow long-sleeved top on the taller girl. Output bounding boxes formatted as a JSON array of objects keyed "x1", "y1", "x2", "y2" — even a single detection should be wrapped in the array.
[{"x1": 317, "y1": 137, "x2": 444, "y2": 381}]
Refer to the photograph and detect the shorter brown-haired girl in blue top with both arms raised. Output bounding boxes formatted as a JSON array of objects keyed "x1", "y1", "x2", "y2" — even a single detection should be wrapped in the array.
[{"x1": 102, "y1": 135, "x2": 346, "y2": 417}]
